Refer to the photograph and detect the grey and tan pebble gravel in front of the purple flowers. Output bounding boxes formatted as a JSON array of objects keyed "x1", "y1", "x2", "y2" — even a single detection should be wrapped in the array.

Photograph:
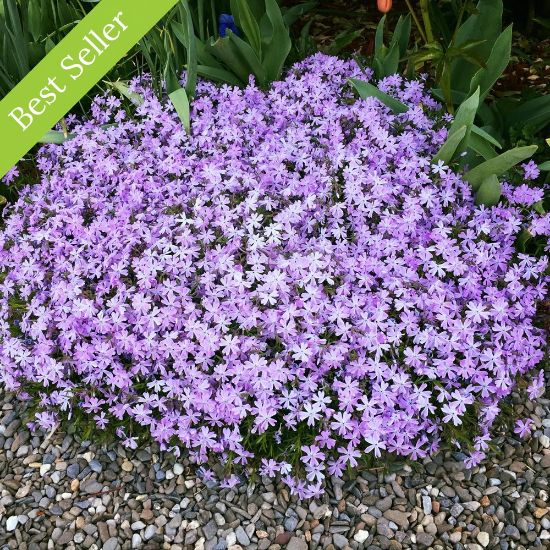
[{"x1": 0, "y1": 388, "x2": 550, "y2": 550}]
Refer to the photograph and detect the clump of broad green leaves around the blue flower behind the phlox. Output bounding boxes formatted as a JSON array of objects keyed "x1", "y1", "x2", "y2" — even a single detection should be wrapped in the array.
[{"x1": 139, "y1": 0, "x2": 312, "y2": 93}]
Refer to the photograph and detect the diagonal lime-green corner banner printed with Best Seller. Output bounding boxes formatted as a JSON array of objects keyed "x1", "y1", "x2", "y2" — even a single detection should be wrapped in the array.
[{"x1": 0, "y1": 0, "x2": 178, "y2": 178}]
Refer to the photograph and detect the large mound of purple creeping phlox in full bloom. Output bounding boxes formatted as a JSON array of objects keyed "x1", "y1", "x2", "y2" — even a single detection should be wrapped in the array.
[{"x1": 0, "y1": 55, "x2": 549, "y2": 497}]
